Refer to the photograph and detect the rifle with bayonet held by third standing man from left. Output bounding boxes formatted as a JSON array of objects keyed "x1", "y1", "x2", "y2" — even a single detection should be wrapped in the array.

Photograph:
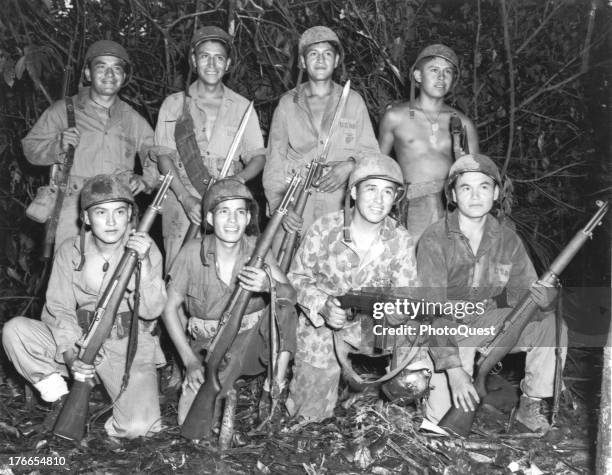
[{"x1": 277, "y1": 79, "x2": 351, "y2": 273}]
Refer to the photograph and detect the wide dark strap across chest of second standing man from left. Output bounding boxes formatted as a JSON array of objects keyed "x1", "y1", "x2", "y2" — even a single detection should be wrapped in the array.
[{"x1": 174, "y1": 91, "x2": 211, "y2": 196}]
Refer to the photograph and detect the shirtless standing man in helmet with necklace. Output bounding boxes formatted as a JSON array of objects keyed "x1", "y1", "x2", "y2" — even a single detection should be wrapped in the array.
[{"x1": 378, "y1": 44, "x2": 478, "y2": 241}]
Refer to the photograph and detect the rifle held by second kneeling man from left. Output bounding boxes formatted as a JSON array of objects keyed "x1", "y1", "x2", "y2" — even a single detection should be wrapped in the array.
[{"x1": 181, "y1": 174, "x2": 300, "y2": 439}]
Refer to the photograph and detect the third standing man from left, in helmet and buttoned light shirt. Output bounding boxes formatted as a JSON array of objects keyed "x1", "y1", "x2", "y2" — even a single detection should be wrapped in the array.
[{"x1": 263, "y1": 26, "x2": 378, "y2": 249}]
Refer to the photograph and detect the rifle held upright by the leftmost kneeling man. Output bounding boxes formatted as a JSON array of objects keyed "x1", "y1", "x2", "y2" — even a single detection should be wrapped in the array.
[{"x1": 53, "y1": 174, "x2": 172, "y2": 441}]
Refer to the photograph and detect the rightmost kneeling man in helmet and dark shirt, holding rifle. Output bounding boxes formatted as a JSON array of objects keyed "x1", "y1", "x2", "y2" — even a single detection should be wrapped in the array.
[{"x1": 417, "y1": 154, "x2": 557, "y2": 431}]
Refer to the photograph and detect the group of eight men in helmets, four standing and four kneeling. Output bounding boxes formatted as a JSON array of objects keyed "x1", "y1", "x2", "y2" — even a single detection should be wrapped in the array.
[{"x1": 2, "y1": 26, "x2": 556, "y2": 438}]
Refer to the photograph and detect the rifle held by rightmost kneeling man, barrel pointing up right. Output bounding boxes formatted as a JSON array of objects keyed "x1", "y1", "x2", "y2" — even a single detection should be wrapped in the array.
[{"x1": 438, "y1": 201, "x2": 608, "y2": 437}]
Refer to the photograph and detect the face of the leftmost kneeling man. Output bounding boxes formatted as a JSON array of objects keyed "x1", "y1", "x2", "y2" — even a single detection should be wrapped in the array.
[{"x1": 84, "y1": 201, "x2": 132, "y2": 244}]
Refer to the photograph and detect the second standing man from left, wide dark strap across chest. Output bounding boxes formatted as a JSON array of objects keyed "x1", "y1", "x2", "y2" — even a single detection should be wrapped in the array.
[{"x1": 155, "y1": 26, "x2": 265, "y2": 268}]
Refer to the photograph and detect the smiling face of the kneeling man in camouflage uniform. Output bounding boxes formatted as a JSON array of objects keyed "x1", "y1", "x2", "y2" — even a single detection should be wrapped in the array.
[{"x1": 351, "y1": 178, "x2": 398, "y2": 224}]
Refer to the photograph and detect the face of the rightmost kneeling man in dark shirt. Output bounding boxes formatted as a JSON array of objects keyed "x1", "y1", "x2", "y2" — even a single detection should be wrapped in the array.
[{"x1": 452, "y1": 172, "x2": 499, "y2": 218}]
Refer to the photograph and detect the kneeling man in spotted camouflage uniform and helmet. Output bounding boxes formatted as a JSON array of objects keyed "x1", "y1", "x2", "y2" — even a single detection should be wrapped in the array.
[{"x1": 287, "y1": 152, "x2": 426, "y2": 421}]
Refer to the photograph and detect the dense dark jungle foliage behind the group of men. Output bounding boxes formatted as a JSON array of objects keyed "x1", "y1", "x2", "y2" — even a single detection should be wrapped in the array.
[{"x1": 0, "y1": 0, "x2": 610, "y2": 324}]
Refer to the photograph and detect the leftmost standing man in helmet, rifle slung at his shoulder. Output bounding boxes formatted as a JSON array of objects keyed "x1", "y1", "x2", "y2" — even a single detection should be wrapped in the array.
[{"x1": 22, "y1": 40, "x2": 158, "y2": 246}]
